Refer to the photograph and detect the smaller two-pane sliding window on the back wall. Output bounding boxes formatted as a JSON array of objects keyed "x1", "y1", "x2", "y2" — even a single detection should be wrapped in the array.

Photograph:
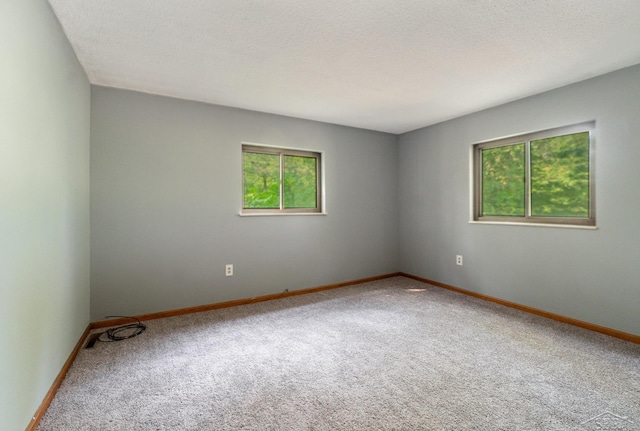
[{"x1": 242, "y1": 145, "x2": 323, "y2": 214}]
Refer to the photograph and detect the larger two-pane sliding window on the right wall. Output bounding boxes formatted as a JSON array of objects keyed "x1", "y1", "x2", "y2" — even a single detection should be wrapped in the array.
[{"x1": 473, "y1": 122, "x2": 595, "y2": 226}]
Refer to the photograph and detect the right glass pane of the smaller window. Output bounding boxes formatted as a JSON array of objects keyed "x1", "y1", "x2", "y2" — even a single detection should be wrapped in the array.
[{"x1": 284, "y1": 155, "x2": 318, "y2": 208}]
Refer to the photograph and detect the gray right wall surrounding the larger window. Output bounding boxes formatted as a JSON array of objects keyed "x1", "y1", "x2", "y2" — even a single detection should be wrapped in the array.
[{"x1": 399, "y1": 66, "x2": 640, "y2": 334}]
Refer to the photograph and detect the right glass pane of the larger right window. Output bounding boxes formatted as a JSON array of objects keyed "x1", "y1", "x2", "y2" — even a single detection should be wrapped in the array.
[{"x1": 530, "y1": 132, "x2": 589, "y2": 218}]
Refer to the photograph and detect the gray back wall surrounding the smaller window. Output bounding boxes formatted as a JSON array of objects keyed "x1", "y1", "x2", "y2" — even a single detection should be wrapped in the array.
[{"x1": 91, "y1": 87, "x2": 398, "y2": 320}]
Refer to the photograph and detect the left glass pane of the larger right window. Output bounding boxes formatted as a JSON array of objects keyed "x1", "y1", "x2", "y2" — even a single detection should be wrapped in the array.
[{"x1": 482, "y1": 143, "x2": 525, "y2": 216}]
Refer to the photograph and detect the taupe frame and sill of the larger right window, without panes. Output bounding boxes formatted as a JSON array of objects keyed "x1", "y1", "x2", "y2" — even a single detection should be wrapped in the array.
[{"x1": 471, "y1": 121, "x2": 596, "y2": 227}]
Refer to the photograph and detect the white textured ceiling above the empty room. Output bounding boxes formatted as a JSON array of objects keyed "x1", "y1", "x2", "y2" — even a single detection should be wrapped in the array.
[{"x1": 49, "y1": 0, "x2": 640, "y2": 133}]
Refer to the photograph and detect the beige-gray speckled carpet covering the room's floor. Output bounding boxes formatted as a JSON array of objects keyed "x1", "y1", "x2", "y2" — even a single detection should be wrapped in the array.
[{"x1": 39, "y1": 277, "x2": 640, "y2": 431}]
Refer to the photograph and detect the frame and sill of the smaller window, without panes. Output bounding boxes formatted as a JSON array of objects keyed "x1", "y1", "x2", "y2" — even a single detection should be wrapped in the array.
[{"x1": 239, "y1": 142, "x2": 326, "y2": 216}]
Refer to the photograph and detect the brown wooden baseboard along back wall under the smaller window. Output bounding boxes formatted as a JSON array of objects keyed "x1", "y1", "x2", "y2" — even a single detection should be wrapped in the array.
[{"x1": 90, "y1": 272, "x2": 400, "y2": 329}]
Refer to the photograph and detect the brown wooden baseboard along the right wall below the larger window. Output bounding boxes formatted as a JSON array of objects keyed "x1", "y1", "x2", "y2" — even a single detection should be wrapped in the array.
[{"x1": 400, "y1": 272, "x2": 640, "y2": 344}]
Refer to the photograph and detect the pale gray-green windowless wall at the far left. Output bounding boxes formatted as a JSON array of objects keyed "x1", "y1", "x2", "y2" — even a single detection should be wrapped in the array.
[{"x1": 0, "y1": 0, "x2": 90, "y2": 430}]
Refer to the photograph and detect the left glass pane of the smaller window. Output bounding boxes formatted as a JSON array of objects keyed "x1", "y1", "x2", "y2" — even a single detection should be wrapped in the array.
[{"x1": 243, "y1": 152, "x2": 280, "y2": 209}]
